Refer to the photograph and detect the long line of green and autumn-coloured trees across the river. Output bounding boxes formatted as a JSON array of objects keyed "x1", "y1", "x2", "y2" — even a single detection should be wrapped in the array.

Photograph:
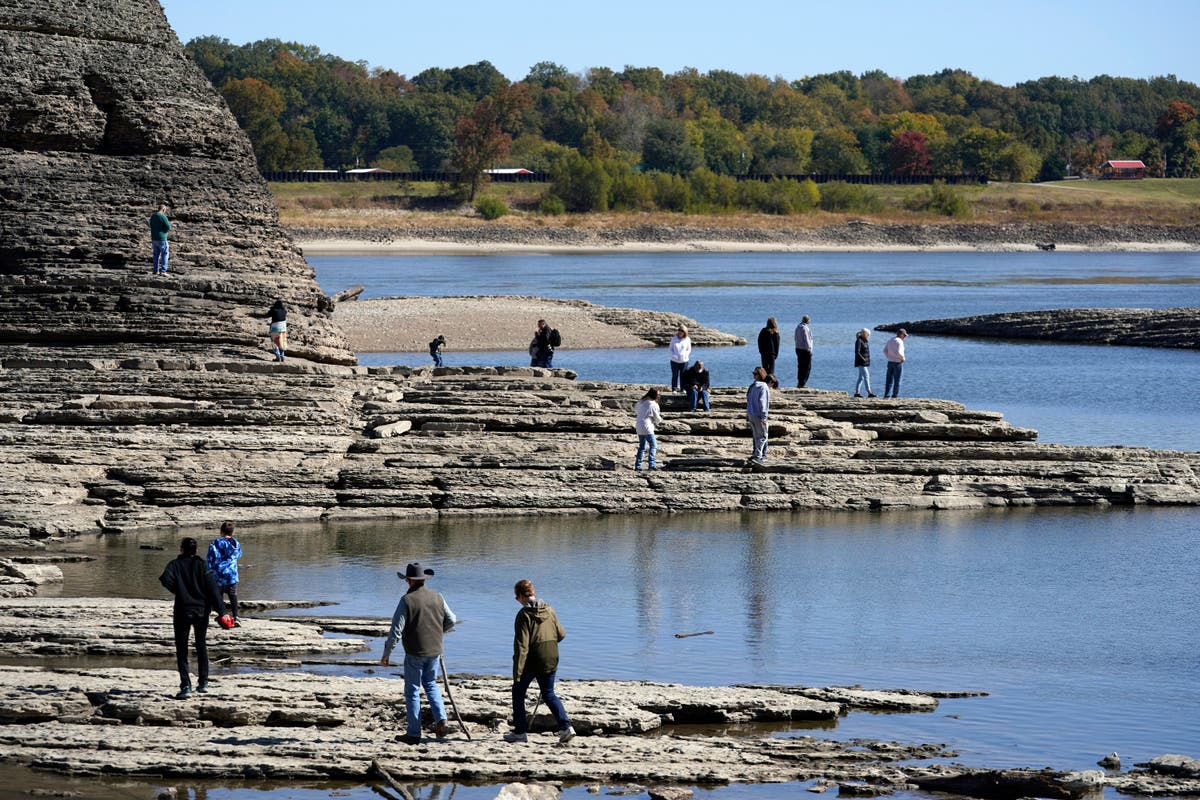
[{"x1": 186, "y1": 36, "x2": 1200, "y2": 196}]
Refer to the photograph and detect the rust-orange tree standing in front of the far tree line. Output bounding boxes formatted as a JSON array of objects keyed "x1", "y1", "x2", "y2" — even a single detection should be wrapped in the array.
[{"x1": 450, "y1": 83, "x2": 529, "y2": 200}]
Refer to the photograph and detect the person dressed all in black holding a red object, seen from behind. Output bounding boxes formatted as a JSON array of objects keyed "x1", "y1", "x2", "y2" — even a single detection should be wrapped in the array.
[{"x1": 158, "y1": 536, "x2": 226, "y2": 699}]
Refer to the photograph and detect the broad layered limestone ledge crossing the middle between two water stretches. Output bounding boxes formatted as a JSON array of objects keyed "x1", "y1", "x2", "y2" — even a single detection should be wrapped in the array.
[{"x1": 0, "y1": 357, "x2": 1200, "y2": 549}]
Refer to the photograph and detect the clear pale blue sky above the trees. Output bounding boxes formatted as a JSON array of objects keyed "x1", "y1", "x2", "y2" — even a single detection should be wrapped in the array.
[{"x1": 163, "y1": 0, "x2": 1200, "y2": 86}]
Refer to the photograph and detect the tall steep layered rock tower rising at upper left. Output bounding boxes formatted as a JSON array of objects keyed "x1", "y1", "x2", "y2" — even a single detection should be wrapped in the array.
[{"x1": 0, "y1": 0, "x2": 354, "y2": 363}]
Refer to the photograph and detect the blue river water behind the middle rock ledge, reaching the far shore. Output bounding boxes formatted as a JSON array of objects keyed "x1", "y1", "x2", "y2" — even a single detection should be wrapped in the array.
[{"x1": 308, "y1": 253, "x2": 1200, "y2": 450}]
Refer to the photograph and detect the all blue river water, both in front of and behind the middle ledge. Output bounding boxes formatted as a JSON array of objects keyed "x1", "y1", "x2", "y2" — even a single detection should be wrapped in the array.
[{"x1": 28, "y1": 253, "x2": 1200, "y2": 800}]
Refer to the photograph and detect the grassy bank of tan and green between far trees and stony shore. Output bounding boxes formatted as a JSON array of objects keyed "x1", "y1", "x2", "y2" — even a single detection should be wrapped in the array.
[{"x1": 270, "y1": 179, "x2": 1200, "y2": 228}]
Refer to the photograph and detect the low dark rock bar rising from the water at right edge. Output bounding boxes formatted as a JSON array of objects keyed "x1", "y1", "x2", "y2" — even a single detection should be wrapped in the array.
[{"x1": 875, "y1": 308, "x2": 1200, "y2": 350}]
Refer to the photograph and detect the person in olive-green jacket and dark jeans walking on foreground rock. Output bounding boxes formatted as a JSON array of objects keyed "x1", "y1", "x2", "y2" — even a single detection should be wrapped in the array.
[{"x1": 504, "y1": 581, "x2": 575, "y2": 744}]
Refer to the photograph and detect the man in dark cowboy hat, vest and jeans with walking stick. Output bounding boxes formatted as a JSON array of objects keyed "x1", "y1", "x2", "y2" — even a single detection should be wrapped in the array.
[{"x1": 379, "y1": 561, "x2": 458, "y2": 745}]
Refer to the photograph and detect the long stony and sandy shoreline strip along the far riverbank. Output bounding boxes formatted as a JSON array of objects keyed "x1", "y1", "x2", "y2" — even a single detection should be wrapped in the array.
[{"x1": 289, "y1": 219, "x2": 1200, "y2": 258}]
